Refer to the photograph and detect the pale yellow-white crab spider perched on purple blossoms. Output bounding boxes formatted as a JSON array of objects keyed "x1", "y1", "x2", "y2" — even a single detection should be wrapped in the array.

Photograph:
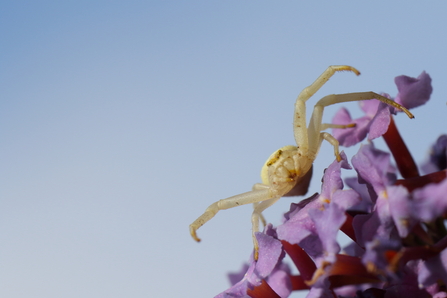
[{"x1": 189, "y1": 65, "x2": 414, "y2": 260}]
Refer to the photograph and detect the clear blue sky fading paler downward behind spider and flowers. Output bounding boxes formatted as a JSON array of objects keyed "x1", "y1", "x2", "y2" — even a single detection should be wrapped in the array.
[{"x1": 0, "y1": 1, "x2": 447, "y2": 298}]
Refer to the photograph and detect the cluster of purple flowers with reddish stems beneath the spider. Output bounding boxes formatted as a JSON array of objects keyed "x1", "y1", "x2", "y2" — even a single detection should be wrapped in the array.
[{"x1": 216, "y1": 72, "x2": 447, "y2": 298}]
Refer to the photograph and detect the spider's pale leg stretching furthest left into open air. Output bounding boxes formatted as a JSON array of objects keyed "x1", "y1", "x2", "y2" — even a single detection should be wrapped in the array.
[{"x1": 189, "y1": 188, "x2": 271, "y2": 242}]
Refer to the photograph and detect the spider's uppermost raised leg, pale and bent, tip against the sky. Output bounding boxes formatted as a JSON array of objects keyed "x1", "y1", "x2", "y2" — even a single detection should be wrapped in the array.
[{"x1": 293, "y1": 65, "x2": 360, "y2": 156}]
